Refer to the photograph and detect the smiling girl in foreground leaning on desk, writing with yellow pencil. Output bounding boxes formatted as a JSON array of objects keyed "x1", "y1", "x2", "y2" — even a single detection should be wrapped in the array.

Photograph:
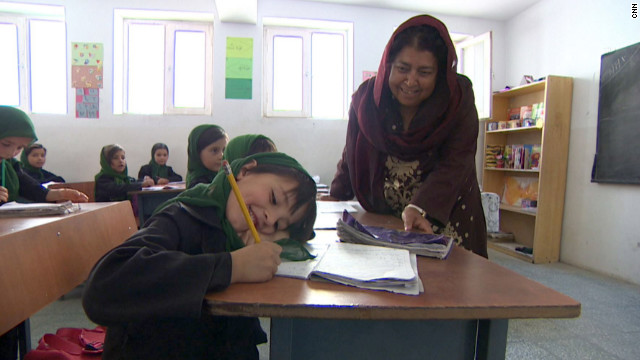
[{"x1": 82, "y1": 153, "x2": 316, "y2": 360}]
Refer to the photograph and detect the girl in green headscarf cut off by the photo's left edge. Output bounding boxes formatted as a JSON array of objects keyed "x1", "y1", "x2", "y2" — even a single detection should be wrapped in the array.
[{"x1": 0, "y1": 106, "x2": 88, "y2": 203}]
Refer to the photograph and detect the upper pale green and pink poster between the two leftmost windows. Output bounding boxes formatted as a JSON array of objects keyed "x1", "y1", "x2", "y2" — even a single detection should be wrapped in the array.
[{"x1": 71, "y1": 42, "x2": 104, "y2": 89}]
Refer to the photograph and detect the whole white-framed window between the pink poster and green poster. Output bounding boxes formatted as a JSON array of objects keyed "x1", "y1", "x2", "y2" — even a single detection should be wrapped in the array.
[{"x1": 113, "y1": 10, "x2": 213, "y2": 115}]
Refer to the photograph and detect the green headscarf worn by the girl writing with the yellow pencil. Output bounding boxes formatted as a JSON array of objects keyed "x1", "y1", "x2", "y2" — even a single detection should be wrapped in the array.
[{"x1": 155, "y1": 152, "x2": 313, "y2": 260}]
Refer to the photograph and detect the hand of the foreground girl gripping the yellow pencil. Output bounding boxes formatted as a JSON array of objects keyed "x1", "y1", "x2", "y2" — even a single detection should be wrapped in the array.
[{"x1": 231, "y1": 241, "x2": 282, "y2": 284}]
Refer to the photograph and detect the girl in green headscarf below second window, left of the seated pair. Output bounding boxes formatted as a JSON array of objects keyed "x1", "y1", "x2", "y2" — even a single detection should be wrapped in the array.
[{"x1": 95, "y1": 144, "x2": 153, "y2": 202}]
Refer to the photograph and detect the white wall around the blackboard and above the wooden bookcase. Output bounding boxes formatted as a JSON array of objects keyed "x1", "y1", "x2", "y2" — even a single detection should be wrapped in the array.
[{"x1": 503, "y1": 0, "x2": 640, "y2": 284}]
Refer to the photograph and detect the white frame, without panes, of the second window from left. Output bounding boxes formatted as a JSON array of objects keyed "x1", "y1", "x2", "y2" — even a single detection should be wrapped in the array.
[{"x1": 112, "y1": 9, "x2": 214, "y2": 116}]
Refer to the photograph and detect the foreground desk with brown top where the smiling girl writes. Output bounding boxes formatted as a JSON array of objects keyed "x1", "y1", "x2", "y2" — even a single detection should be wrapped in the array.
[{"x1": 207, "y1": 213, "x2": 580, "y2": 360}]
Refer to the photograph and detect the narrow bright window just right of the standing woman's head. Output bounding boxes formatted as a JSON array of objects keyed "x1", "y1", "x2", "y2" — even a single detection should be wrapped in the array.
[{"x1": 452, "y1": 32, "x2": 491, "y2": 119}]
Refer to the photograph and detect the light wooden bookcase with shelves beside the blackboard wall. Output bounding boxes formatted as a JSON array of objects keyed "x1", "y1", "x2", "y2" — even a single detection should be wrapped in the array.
[{"x1": 482, "y1": 76, "x2": 573, "y2": 263}]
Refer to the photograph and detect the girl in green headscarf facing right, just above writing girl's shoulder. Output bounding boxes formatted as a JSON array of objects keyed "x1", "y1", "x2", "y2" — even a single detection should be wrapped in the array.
[{"x1": 186, "y1": 124, "x2": 229, "y2": 189}]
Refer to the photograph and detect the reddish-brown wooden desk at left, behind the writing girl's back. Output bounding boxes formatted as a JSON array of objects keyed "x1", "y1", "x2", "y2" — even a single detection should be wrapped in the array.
[{"x1": 0, "y1": 201, "x2": 137, "y2": 355}]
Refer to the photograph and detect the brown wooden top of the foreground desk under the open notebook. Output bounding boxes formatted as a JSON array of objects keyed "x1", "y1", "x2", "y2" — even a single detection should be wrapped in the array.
[{"x1": 207, "y1": 213, "x2": 580, "y2": 320}]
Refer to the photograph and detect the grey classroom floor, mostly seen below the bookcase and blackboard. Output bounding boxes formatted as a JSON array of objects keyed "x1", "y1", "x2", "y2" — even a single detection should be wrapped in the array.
[{"x1": 26, "y1": 250, "x2": 640, "y2": 360}]
